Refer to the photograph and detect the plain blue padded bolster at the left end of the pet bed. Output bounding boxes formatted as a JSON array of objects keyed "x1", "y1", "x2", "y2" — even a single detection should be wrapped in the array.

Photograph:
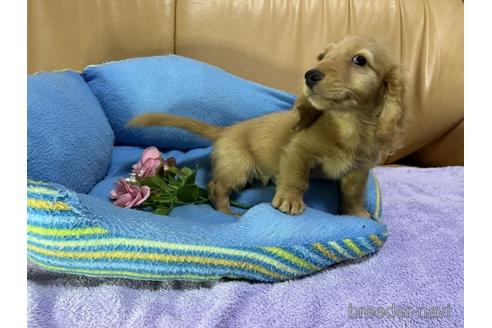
[{"x1": 27, "y1": 71, "x2": 114, "y2": 193}]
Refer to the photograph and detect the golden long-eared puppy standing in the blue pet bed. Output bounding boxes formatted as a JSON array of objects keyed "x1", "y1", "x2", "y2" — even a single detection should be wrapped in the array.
[{"x1": 129, "y1": 36, "x2": 404, "y2": 217}]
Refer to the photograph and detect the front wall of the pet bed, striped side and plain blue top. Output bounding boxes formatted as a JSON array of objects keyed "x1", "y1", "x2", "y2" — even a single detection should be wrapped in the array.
[{"x1": 27, "y1": 173, "x2": 387, "y2": 282}]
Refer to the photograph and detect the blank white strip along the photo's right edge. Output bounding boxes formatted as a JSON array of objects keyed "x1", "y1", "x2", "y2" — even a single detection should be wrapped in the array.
[{"x1": 466, "y1": 1, "x2": 492, "y2": 327}]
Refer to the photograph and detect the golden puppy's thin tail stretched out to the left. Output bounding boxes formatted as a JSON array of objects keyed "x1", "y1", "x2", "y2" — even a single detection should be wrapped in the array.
[{"x1": 127, "y1": 113, "x2": 224, "y2": 141}]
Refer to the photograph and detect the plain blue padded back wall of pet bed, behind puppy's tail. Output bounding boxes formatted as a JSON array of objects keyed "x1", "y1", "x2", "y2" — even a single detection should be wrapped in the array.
[{"x1": 83, "y1": 55, "x2": 295, "y2": 149}]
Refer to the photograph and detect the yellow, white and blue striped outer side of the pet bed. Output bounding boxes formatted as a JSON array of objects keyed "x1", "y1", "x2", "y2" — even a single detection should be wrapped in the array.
[{"x1": 27, "y1": 181, "x2": 386, "y2": 282}]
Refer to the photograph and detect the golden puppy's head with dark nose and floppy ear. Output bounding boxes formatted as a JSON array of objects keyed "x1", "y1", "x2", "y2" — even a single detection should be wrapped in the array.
[{"x1": 301, "y1": 36, "x2": 403, "y2": 152}]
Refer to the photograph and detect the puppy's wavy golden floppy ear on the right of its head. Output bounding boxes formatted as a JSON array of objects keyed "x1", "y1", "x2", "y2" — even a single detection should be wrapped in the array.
[{"x1": 377, "y1": 65, "x2": 405, "y2": 154}]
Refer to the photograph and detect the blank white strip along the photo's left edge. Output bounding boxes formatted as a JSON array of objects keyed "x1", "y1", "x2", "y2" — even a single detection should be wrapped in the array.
[{"x1": 0, "y1": 1, "x2": 27, "y2": 327}]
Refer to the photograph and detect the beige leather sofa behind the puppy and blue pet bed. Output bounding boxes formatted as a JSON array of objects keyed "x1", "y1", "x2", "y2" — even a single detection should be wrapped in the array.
[{"x1": 28, "y1": 0, "x2": 464, "y2": 166}]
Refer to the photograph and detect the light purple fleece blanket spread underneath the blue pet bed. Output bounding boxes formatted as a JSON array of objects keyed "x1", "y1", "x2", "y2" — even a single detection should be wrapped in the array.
[{"x1": 28, "y1": 167, "x2": 464, "y2": 328}]
